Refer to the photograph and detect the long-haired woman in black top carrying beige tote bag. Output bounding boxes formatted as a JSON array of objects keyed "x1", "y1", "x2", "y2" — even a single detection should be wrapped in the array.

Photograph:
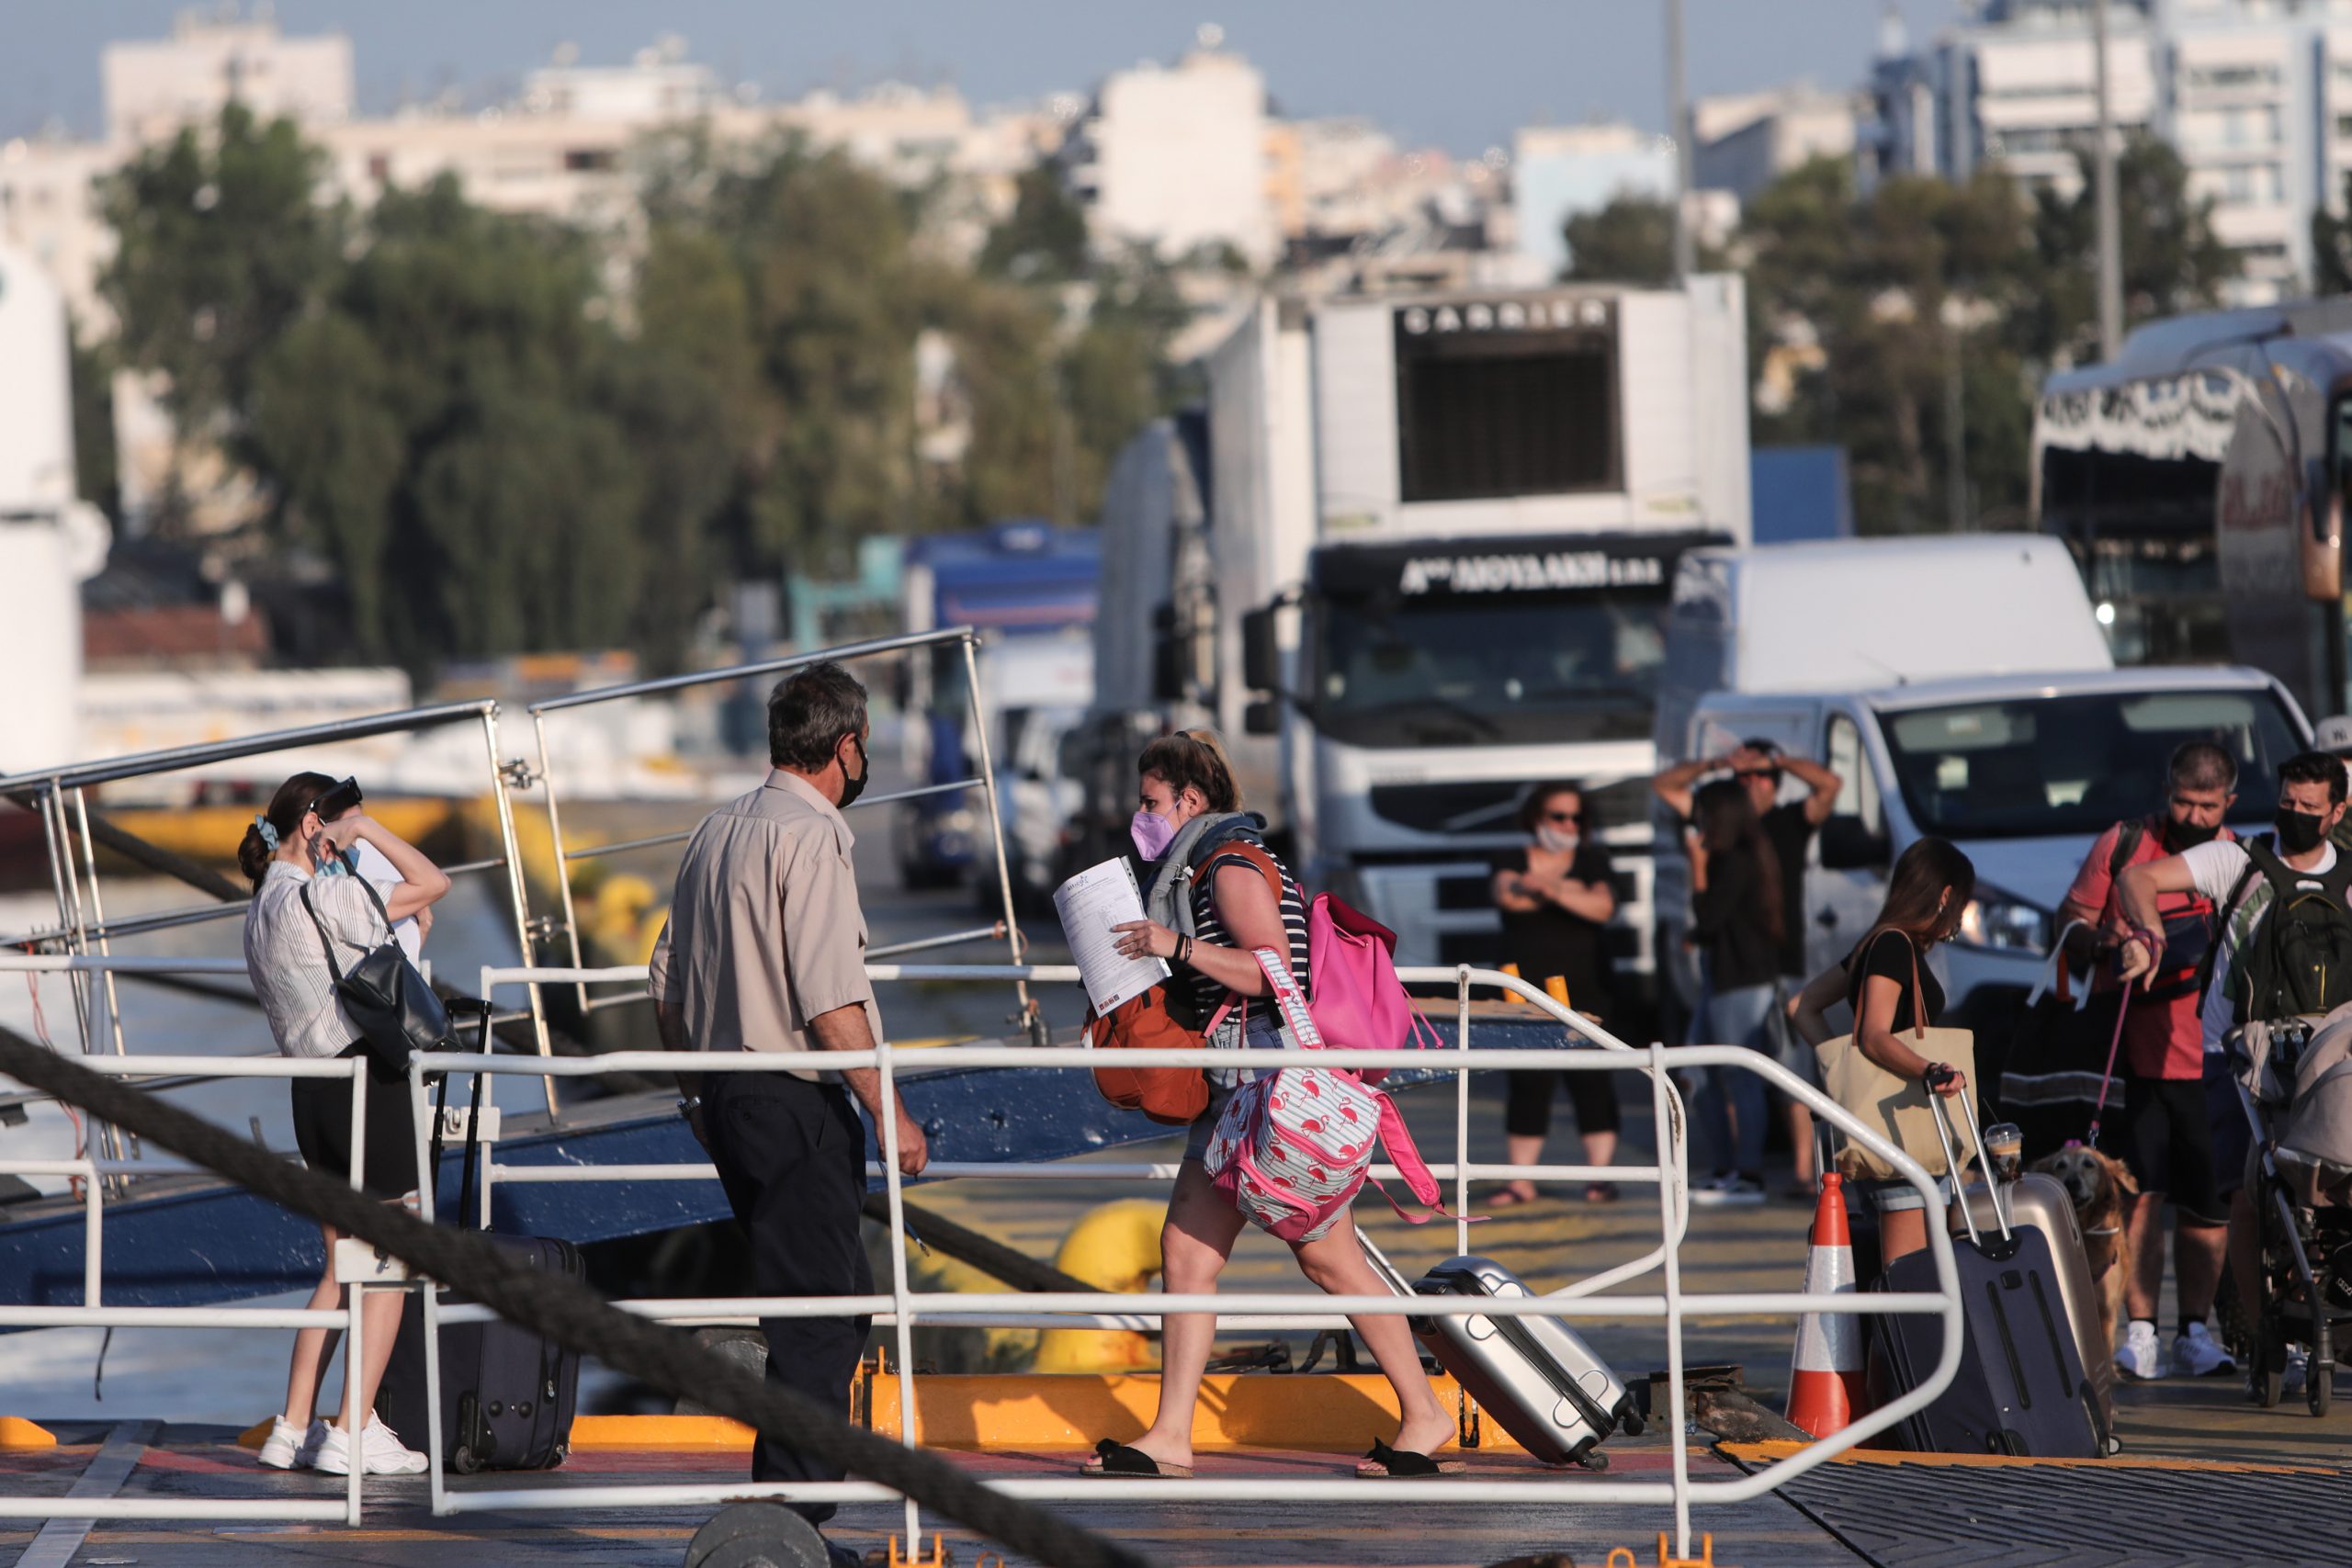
[{"x1": 1790, "y1": 840, "x2": 1975, "y2": 1262}]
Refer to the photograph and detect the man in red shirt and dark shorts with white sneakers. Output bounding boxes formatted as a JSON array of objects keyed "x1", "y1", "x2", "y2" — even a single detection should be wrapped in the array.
[{"x1": 2058, "y1": 740, "x2": 2237, "y2": 1378}]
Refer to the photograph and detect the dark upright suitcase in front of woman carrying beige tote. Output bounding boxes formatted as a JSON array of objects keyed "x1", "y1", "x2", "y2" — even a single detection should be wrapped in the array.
[{"x1": 1870, "y1": 1093, "x2": 2108, "y2": 1460}]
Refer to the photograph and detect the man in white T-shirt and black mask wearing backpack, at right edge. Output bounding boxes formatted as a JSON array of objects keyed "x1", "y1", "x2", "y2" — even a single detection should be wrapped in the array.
[{"x1": 2117, "y1": 752, "x2": 2352, "y2": 1373}]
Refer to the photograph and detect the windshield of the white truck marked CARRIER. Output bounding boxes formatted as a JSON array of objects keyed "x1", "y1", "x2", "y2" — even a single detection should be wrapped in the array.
[{"x1": 1310, "y1": 592, "x2": 1668, "y2": 748}]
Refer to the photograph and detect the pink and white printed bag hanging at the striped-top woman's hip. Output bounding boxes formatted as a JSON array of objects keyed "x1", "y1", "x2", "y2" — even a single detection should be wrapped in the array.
[{"x1": 1204, "y1": 949, "x2": 1446, "y2": 1241}]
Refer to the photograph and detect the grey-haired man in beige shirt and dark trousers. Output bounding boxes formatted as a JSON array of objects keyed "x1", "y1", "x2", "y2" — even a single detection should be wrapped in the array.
[{"x1": 650, "y1": 663, "x2": 929, "y2": 1561}]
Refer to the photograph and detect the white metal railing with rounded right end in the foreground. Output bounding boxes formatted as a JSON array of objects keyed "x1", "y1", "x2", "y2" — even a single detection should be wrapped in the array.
[{"x1": 427, "y1": 964, "x2": 1962, "y2": 1554}]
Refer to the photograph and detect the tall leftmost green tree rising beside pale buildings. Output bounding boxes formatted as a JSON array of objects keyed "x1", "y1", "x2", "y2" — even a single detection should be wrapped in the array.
[{"x1": 99, "y1": 104, "x2": 345, "y2": 484}]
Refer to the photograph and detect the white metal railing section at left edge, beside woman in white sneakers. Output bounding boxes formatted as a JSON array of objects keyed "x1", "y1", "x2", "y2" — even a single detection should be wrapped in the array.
[{"x1": 0, "y1": 1048, "x2": 390, "y2": 1526}]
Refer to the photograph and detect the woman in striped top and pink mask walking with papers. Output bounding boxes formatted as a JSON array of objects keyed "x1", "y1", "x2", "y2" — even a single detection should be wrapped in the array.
[{"x1": 1087, "y1": 728, "x2": 1461, "y2": 1476}]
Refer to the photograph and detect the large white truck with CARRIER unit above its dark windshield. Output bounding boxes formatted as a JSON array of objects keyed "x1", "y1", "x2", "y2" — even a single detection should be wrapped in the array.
[{"x1": 1096, "y1": 275, "x2": 1747, "y2": 1006}]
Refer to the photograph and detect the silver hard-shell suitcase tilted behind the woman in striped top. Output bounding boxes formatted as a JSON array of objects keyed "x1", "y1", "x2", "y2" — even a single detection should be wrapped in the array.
[{"x1": 1414, "y1": 1258, "x2": 1642, "y2": 1470}]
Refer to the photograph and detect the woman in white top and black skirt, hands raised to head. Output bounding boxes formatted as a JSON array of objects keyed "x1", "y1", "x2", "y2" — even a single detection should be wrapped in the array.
[{"x1": 238, "y1": 773, "x2": 449, "y2": 1476}]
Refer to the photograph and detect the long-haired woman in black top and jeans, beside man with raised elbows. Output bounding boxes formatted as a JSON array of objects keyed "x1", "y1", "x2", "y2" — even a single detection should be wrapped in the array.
[{"x1": 1689, "y1": 778, "x2": 1785, "y2": 1203}]
